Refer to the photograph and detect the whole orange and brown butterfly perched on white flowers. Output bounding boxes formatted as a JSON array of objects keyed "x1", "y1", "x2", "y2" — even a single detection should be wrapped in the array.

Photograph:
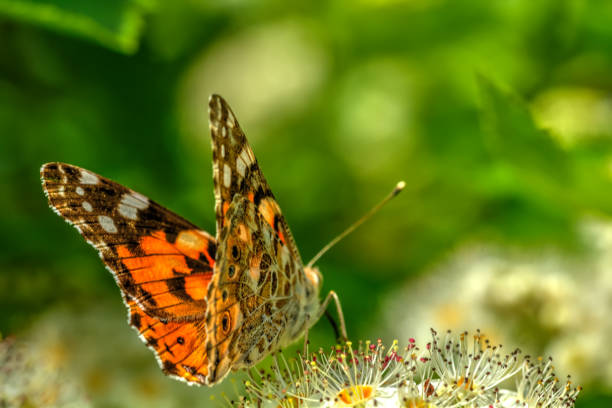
[{"x1": 41, "y1": 95, "x2": 346, "y2": 385}]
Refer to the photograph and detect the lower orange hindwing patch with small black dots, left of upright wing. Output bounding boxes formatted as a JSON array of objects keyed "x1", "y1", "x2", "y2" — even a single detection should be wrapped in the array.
[{"x1": 127, "y1": 299, "x2": 208, "y2": 384}]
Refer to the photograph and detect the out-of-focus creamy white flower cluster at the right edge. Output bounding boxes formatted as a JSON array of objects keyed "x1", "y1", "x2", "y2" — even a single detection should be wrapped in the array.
[{"x1": 376, "y1": 220, "x2": 612, "y2": 387}]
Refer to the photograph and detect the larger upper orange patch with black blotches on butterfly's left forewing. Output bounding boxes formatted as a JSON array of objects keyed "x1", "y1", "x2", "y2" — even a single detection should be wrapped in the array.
[{"x1": 116, "y1": 230, "x2": 215, "y2": 320}]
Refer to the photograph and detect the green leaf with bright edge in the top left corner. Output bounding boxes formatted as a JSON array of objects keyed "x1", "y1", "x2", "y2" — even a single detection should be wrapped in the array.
[{"x1": 0, "y1": 0, "x2": 153, "y2": 54}]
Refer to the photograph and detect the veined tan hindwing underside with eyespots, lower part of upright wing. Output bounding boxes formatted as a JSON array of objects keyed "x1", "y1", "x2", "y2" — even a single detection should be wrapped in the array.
[{"x1": 206, "y1": 196, "x2": 308, "y2": 383}]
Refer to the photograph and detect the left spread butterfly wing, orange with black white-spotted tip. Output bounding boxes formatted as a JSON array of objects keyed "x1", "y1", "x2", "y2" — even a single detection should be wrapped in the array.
[{"x1": 41, "y1": 163, "x2": 216, "y2": 383}]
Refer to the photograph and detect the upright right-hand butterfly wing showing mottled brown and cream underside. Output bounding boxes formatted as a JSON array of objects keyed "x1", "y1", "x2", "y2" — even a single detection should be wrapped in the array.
[{"x1": 206, "y1": 95, "x2": 318, "y2": 383}]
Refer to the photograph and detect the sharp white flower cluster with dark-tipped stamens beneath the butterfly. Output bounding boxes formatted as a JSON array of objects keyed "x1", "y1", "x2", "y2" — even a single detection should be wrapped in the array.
[{"x1": 229, "y1": 330, "x2": 580, "y2": 408}]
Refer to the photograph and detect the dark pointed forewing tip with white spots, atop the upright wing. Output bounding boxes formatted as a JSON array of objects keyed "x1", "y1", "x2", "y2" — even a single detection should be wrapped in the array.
[{"x1": 208, "y1": 95, "x2": 302, "y2": 263}]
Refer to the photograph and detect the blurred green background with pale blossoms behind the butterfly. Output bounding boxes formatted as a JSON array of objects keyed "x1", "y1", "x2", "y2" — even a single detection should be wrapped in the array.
[{"x1": 0, "y1": 0, "x2": 612, "y2": 407}]
